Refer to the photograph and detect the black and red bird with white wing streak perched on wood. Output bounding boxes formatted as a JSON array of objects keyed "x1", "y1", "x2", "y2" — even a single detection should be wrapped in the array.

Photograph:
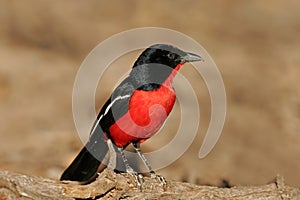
[{"x1": 60, "y1": 44, "x2": 204, "y2": 187}]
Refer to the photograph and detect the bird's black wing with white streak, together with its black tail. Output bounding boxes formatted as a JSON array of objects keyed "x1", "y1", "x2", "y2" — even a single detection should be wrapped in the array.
[{"x1": 61, "y1": 78, "x2": 134, "y2": 183}]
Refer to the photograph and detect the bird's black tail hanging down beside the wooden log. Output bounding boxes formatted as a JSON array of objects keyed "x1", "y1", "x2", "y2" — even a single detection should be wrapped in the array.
[{"x1": 60, "y1": 134, "x2": 108, "y2": 183}]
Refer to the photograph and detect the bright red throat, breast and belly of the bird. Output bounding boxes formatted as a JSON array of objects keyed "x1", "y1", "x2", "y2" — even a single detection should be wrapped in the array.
[{"x1": 109, "y1": 63, "x2": 183, "y2": 147}]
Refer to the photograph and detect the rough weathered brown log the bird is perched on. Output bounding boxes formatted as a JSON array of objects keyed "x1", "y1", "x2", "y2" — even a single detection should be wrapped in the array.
[{"x1": 0, "y1": 170, "x2": 300, "y2": 200}]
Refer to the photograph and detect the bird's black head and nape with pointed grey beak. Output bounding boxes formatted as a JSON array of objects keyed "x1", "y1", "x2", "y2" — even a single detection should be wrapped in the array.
[{"x1": 130, "y1": 44, "x2": 202, "y2": 90}]
